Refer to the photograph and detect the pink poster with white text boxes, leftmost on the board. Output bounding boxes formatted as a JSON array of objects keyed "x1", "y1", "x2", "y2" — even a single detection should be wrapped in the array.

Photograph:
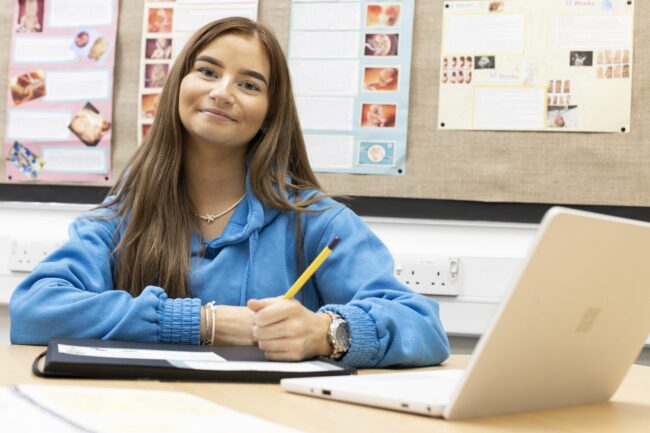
[{"x1": 4, "y1": 0, "x2": 118, "y2": 182}]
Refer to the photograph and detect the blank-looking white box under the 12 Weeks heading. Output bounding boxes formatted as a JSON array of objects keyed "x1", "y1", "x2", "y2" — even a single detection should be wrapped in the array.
[{"x1": 551, "y1": 15, "x2": 634, "y2": 50}]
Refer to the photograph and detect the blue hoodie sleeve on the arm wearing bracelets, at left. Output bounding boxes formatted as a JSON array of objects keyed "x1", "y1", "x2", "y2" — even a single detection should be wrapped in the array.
[{"x1": 9, "y1": 209, "x2": 201, "y2": 344}]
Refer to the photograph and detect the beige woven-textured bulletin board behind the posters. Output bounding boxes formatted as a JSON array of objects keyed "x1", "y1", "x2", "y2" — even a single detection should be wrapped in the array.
[{"x1": 0, "y1": 0, "x2": 650, "y2": 207}]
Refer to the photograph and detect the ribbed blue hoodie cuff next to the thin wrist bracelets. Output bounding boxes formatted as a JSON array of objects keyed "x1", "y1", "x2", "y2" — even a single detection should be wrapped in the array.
[{"x1": 158, "y1": 298, "x2": 201, "y2": 344}]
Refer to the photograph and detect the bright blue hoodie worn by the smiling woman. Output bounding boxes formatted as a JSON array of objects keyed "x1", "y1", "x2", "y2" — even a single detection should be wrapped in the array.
[{"x1": 10, "y1": 184, "x2": 449, "y2": 367}]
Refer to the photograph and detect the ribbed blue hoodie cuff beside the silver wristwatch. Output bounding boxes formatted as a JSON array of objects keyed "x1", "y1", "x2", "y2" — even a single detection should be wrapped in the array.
[{"x1": 318, "y1": 305, "x2": 379, "y2": 368}]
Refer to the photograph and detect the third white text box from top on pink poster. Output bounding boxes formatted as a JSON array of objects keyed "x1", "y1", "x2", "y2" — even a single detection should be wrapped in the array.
[{"x1": 45, "y1": 70, "x2": 111, "y2": 102}]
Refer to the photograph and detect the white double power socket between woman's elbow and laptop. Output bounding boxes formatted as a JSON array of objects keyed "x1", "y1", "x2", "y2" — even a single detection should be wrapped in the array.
[{"x1": 395, "y1": 256, "x2": 460, "y2": 296}]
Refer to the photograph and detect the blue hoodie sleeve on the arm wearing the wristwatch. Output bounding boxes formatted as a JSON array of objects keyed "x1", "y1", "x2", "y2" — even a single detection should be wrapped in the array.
[{"x1": 305, "y1": 208, "x2": 449, "y2": 367}]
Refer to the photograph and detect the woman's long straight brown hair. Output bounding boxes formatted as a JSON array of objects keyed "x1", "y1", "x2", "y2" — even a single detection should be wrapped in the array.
[{"x1": 100, "y1": 17, "x2": 320, "y2": 298}]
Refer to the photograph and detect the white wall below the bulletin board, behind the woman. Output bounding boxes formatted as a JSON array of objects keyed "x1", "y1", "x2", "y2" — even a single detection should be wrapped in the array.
[{"x1": 0, "y1": 202, "x2": 650, "y2": 365}]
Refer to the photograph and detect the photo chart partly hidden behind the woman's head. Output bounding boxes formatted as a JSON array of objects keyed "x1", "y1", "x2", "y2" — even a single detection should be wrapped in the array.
[{"x1": 138, "y1": 0, "x2": 258, "y2": 143}]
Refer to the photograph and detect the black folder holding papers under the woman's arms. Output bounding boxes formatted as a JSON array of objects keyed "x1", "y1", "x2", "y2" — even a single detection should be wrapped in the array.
[{"x1": 32, "y1": 338, "x2": 356, "y2": 383}]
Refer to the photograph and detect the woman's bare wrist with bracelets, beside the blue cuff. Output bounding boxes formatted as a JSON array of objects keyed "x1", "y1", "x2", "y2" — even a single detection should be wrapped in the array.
[{"x1": 201, "y1": 305, "x2": 257, "y2": 346}]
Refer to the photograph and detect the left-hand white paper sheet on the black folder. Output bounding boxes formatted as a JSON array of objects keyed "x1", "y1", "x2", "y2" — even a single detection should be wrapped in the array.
[{"x1": 59, "y1": 344, "x2": 225, "y2": 361}]
